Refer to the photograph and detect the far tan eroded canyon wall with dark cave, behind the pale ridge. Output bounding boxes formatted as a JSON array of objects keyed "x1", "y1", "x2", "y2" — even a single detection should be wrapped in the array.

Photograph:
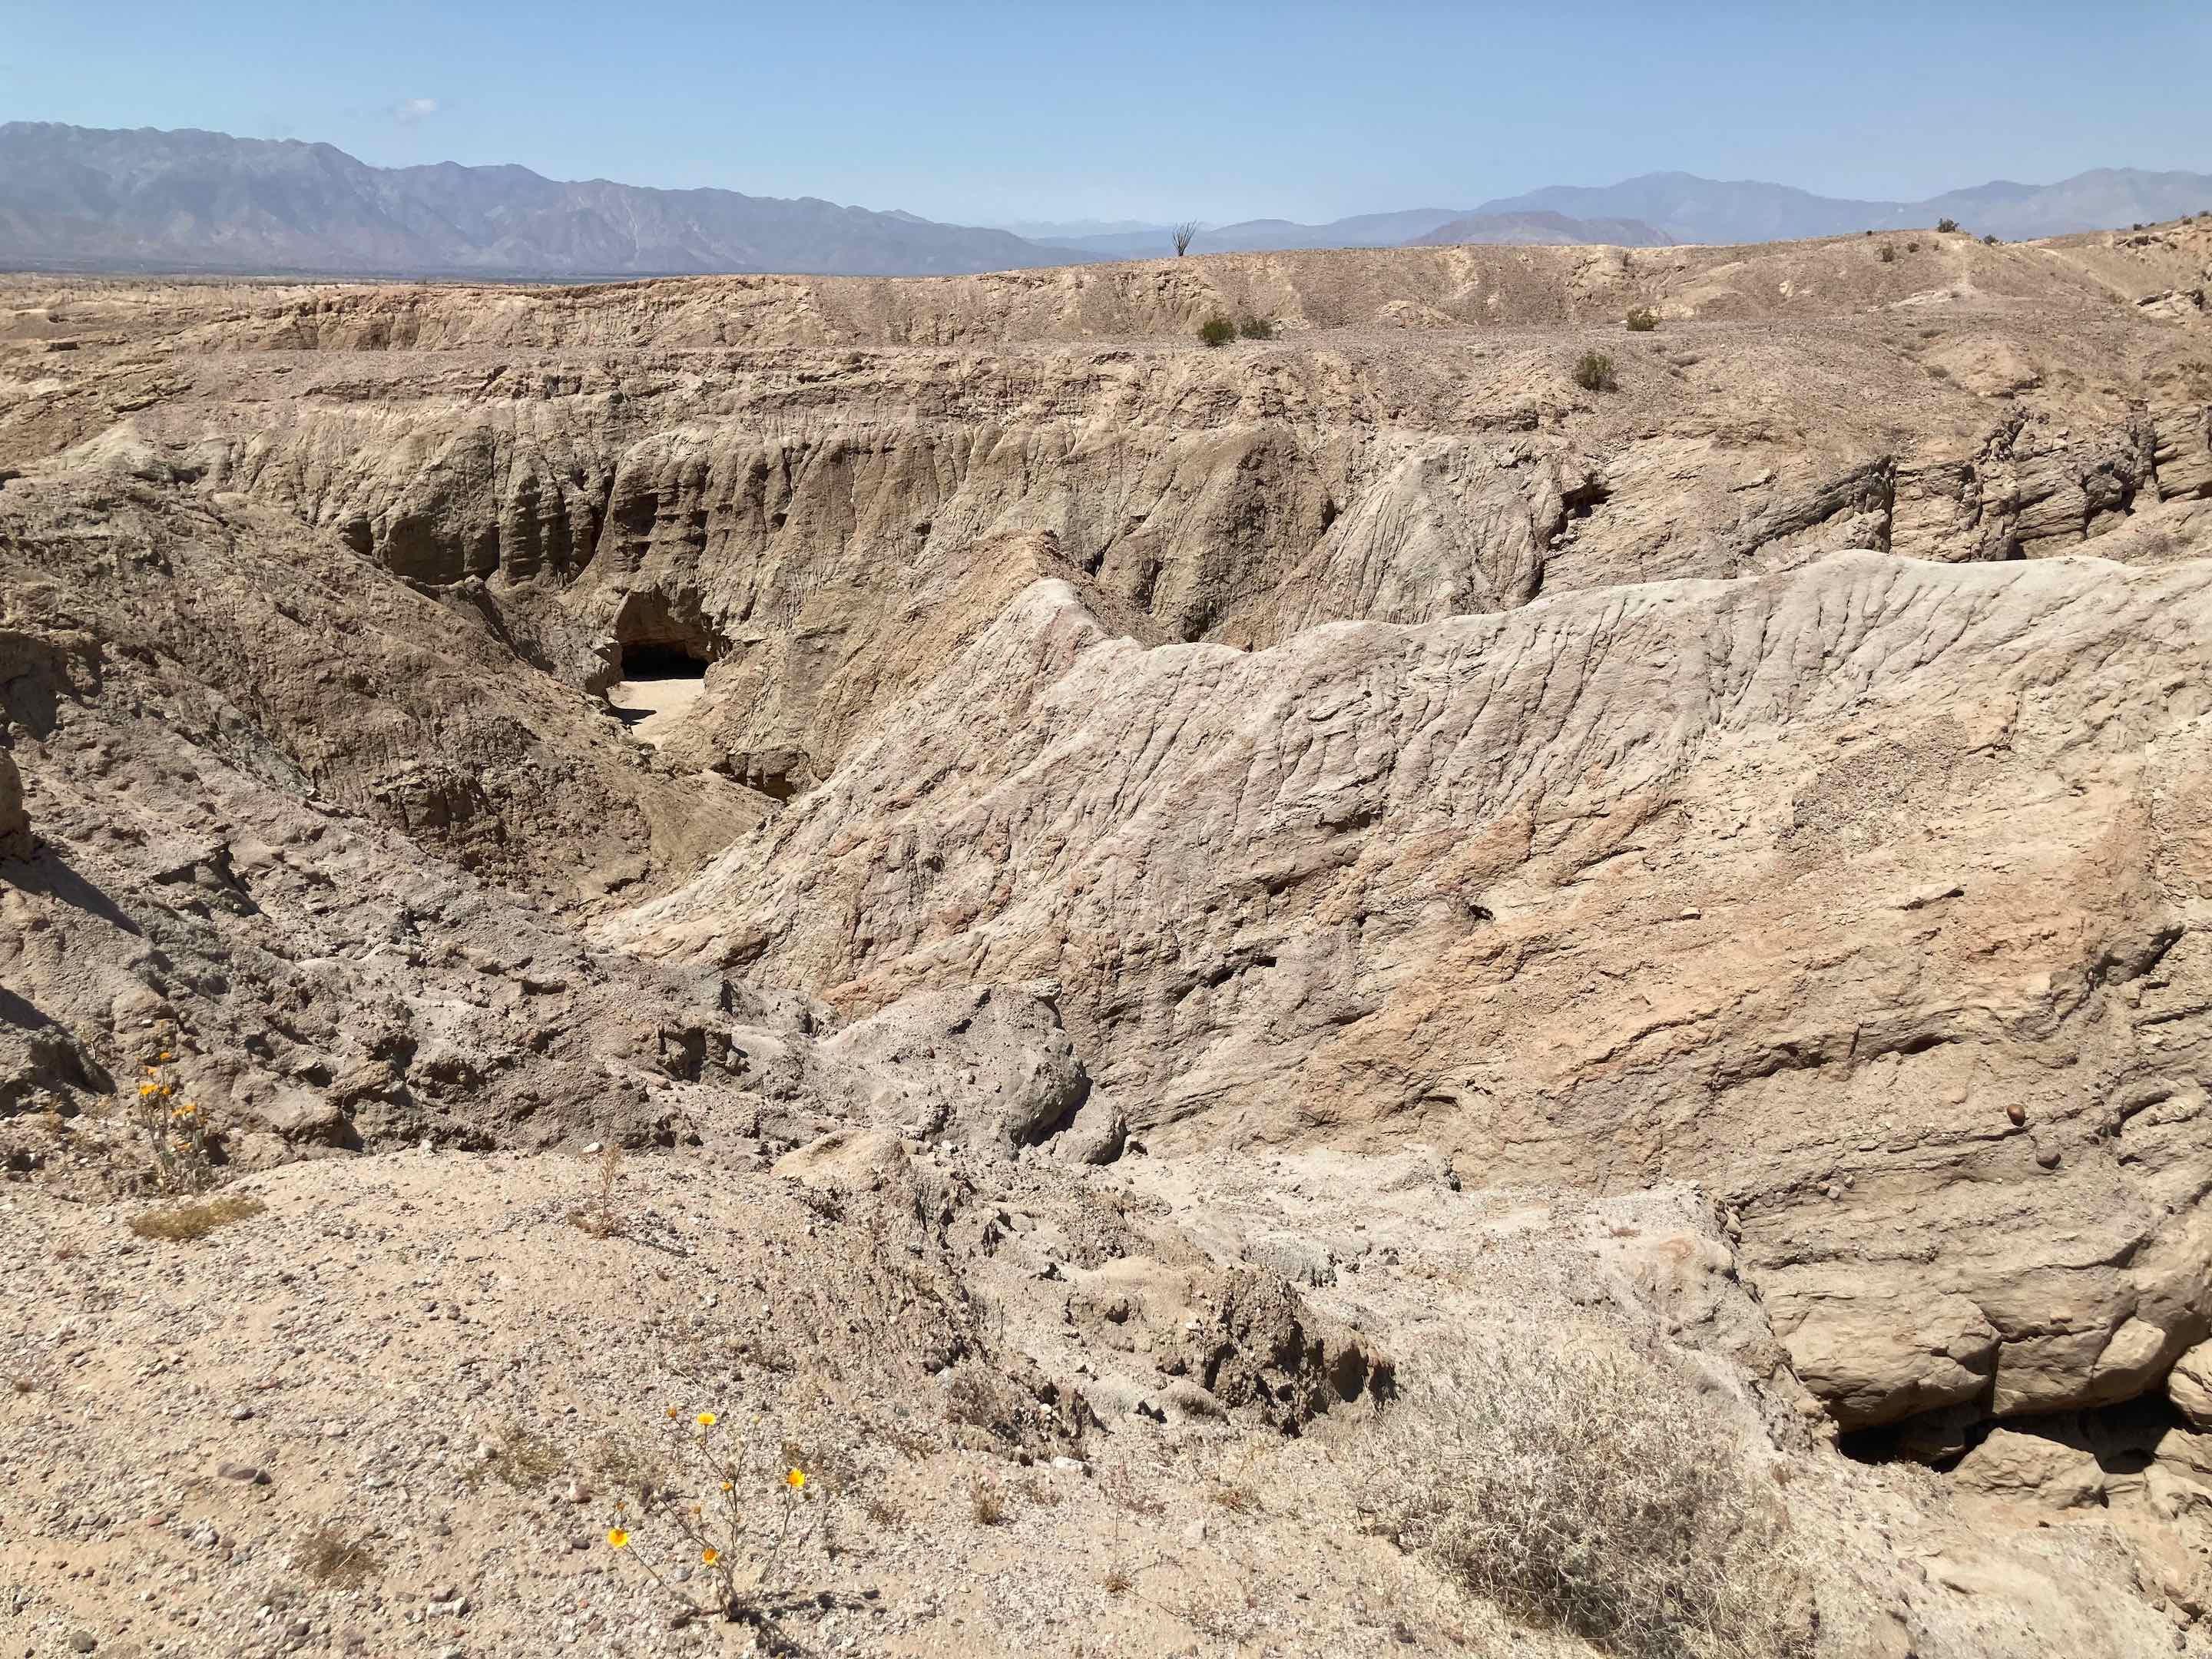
[{"x1": 5, "y1": 228, "x2": 2212, "y2": 813}]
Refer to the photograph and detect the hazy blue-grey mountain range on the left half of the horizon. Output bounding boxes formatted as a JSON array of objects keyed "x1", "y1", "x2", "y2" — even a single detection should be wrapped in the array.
[{"x1": 0, "y1": 121, "x2": 1097, "y2": 276}]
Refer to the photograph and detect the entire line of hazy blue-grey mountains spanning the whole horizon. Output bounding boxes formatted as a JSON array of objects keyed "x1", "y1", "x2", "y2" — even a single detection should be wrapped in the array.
[{"x1": 0, "y1": 121, "x2": 2212, "y2": 279}]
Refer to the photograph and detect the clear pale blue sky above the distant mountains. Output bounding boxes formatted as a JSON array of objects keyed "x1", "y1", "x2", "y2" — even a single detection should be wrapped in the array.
[{"x1": 0, "y1": 0, "x2": 2212, "y2": 224}]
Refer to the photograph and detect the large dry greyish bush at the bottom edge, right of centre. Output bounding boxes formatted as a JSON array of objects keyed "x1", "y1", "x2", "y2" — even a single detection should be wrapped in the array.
[{"x1": 1360, "y1": 1334, "x2": 1812, "y2": 1659}]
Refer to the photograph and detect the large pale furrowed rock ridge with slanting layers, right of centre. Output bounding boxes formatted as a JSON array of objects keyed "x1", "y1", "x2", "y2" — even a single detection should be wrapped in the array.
[{"x1": 618, "y1": 553, "x2": 2212, "y2": 1427}]
